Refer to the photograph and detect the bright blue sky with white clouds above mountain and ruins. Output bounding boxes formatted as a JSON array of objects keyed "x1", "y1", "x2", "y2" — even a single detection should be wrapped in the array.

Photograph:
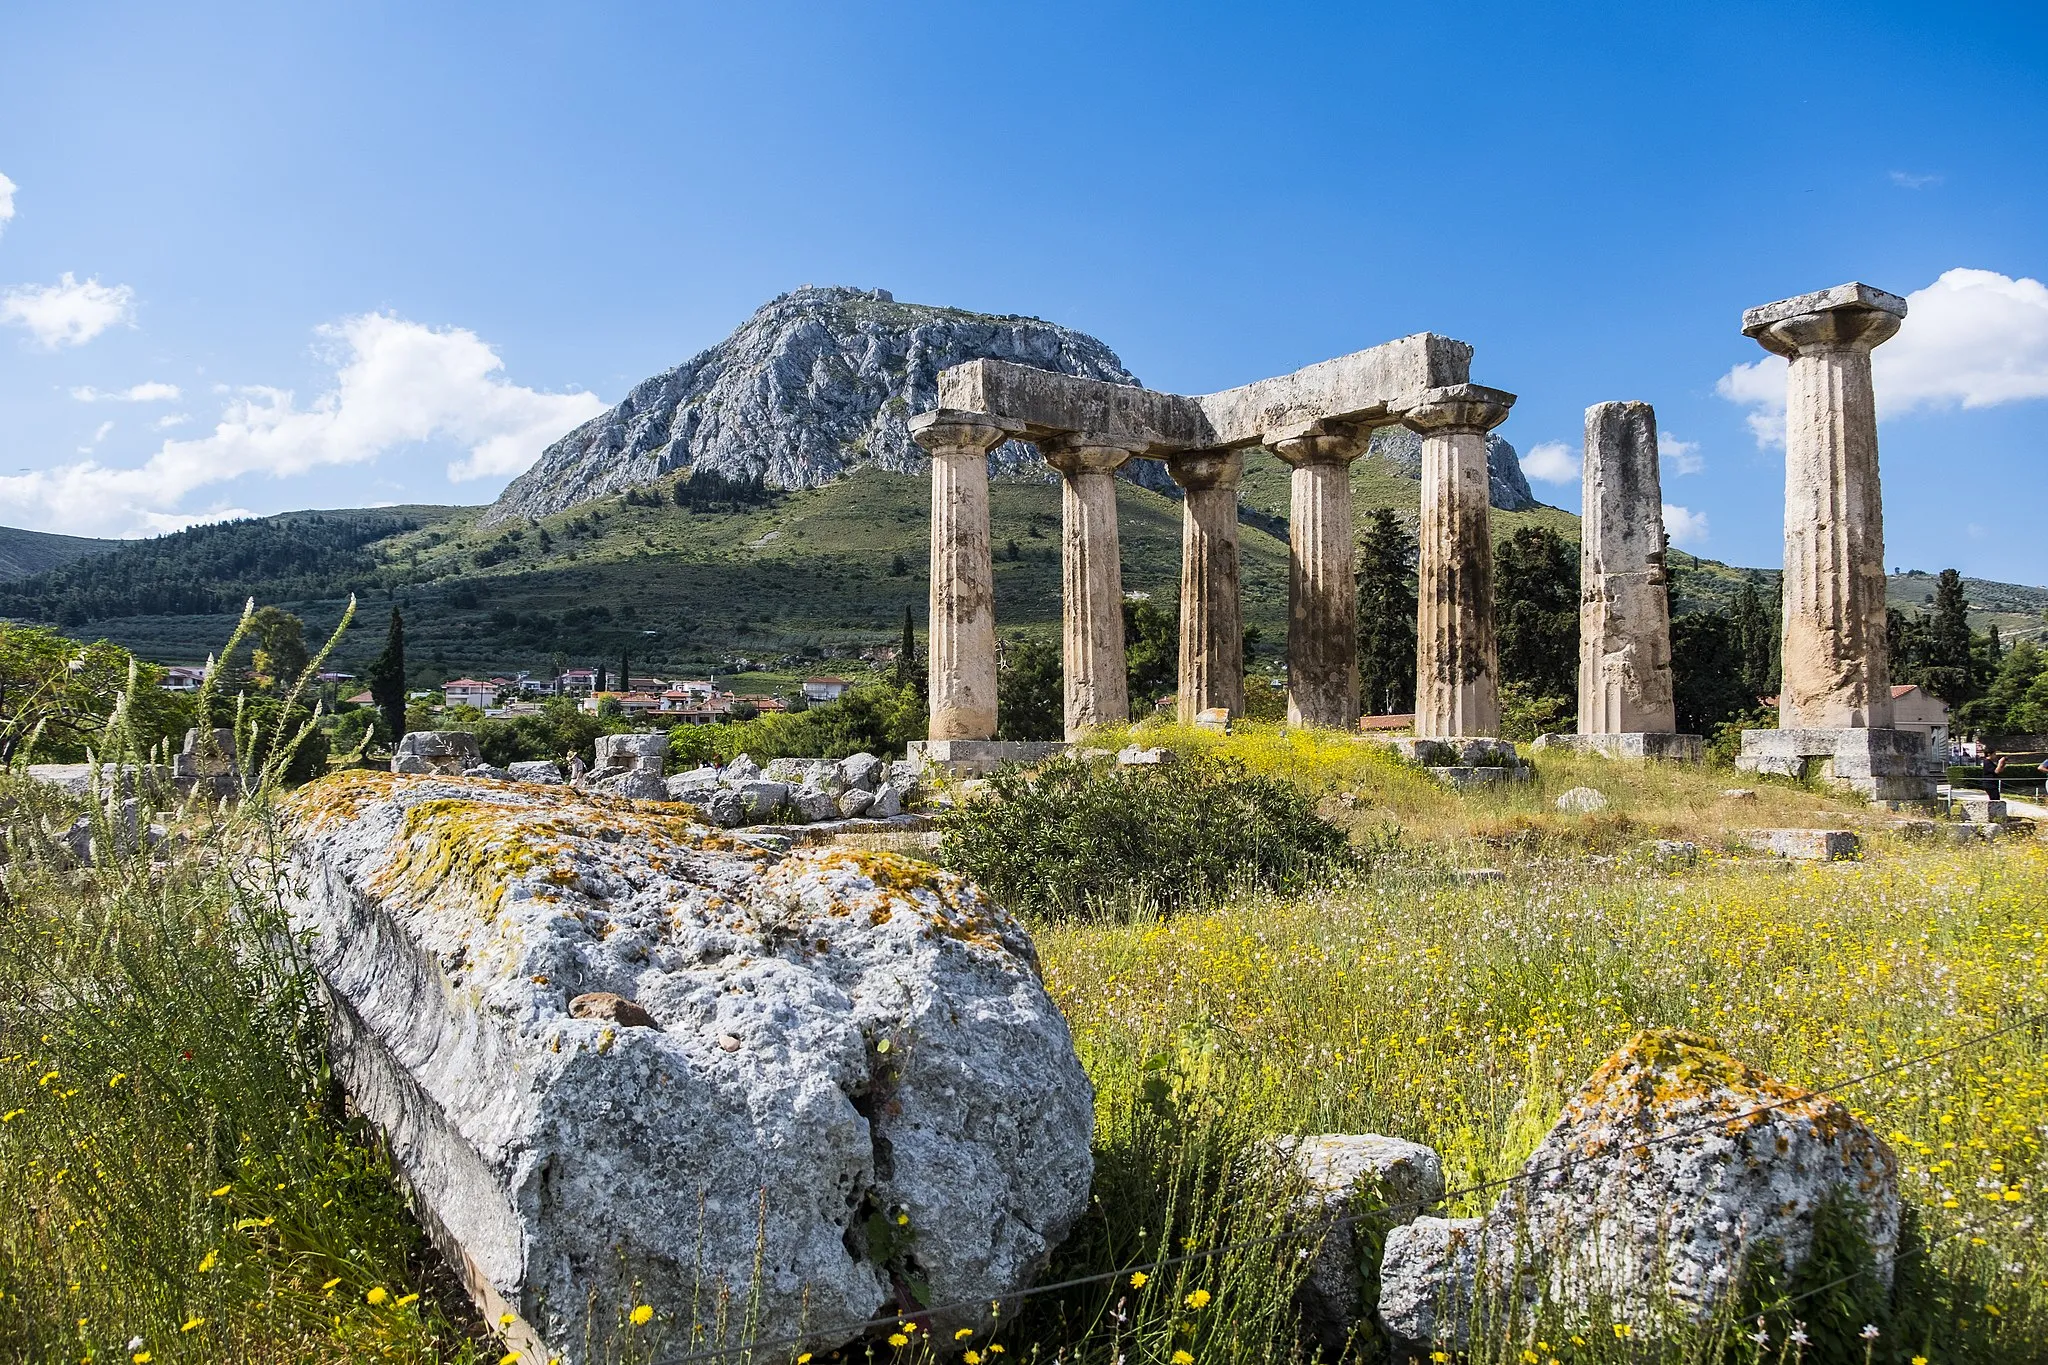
[{"x1": 0, "y1": 2, "x2": 2048, "y2": 583}]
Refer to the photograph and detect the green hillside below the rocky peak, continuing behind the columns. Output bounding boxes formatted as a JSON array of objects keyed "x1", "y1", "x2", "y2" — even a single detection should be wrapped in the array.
[{"x1": 0, "y1": 462, "x2": 2048, "y2": 690}]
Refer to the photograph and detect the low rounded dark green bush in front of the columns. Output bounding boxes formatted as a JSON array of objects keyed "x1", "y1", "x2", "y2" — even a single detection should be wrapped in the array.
[{"x1": 940, "y1": 757, "x2": 1356, "y2": 919}]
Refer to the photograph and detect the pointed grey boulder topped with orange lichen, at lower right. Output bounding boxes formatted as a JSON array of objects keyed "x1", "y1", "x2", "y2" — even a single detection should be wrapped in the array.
[{"x1": 1380, "y1": 1029, "x2": 1898, "y2": 1349}]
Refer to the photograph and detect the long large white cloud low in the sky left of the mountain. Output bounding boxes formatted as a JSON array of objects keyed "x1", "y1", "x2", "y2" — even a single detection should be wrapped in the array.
[{"x1": 0, "y1": 313, "x2": 604, "y2": 534}]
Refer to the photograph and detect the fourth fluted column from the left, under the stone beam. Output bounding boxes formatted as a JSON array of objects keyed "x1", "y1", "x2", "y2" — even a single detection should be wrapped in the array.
[{"x1": 1266, "y1": 422, "x2": 1372, "y2": 731}]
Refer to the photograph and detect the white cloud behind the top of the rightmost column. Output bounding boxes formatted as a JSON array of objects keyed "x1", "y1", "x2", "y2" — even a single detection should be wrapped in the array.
[{"x1": 1714, "y1": 270, "x2": 2048, "y2": 446}]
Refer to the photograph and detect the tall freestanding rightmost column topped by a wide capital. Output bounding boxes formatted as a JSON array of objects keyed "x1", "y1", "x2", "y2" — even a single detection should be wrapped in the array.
[{"x1": 1743, "y1": 284, "x2": 1907, "y2": 731}]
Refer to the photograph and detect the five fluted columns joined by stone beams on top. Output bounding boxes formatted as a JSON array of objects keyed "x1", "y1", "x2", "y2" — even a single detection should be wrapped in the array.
[{"x1": 911, "y1": 332, "x2": 1516, "y2": 767}]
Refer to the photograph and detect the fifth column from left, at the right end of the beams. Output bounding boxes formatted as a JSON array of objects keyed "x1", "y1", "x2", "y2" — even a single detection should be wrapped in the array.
[{"x1": 1401, "y1": 385, "x2": 1516, "y2": 739}]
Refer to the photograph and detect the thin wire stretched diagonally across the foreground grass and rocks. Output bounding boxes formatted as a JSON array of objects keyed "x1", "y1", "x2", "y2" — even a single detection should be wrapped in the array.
[{"x1": 653, "y1": 1009, "x2": 2048, "y2": 1365}]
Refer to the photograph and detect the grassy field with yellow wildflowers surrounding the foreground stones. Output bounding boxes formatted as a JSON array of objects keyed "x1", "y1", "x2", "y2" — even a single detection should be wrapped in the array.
[{"x1": 0, "y1": 726, "x2": 2048, "y2": 1365}]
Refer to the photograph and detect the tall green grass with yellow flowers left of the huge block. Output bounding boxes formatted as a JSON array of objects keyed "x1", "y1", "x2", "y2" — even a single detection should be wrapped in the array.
[{"x1": 0, "y1": 605, "x2": 475, "y2": 1361}]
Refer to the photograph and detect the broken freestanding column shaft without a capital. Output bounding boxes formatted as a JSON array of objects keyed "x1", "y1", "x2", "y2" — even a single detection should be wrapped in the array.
[{"x1": 1579, "y1": 403, "x2": 1677, "y2": 735}]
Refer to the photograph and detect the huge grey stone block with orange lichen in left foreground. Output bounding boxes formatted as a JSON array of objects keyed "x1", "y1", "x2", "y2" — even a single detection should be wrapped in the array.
[{"x1": 287, "y1": 774, "x2": 1094, "y2": 1363}]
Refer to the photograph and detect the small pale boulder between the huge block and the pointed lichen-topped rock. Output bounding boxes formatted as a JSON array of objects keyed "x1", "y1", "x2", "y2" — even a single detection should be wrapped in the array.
[{"x1": 1274, "y1": 1134, "x2": 1444, "y2": 1351}]
